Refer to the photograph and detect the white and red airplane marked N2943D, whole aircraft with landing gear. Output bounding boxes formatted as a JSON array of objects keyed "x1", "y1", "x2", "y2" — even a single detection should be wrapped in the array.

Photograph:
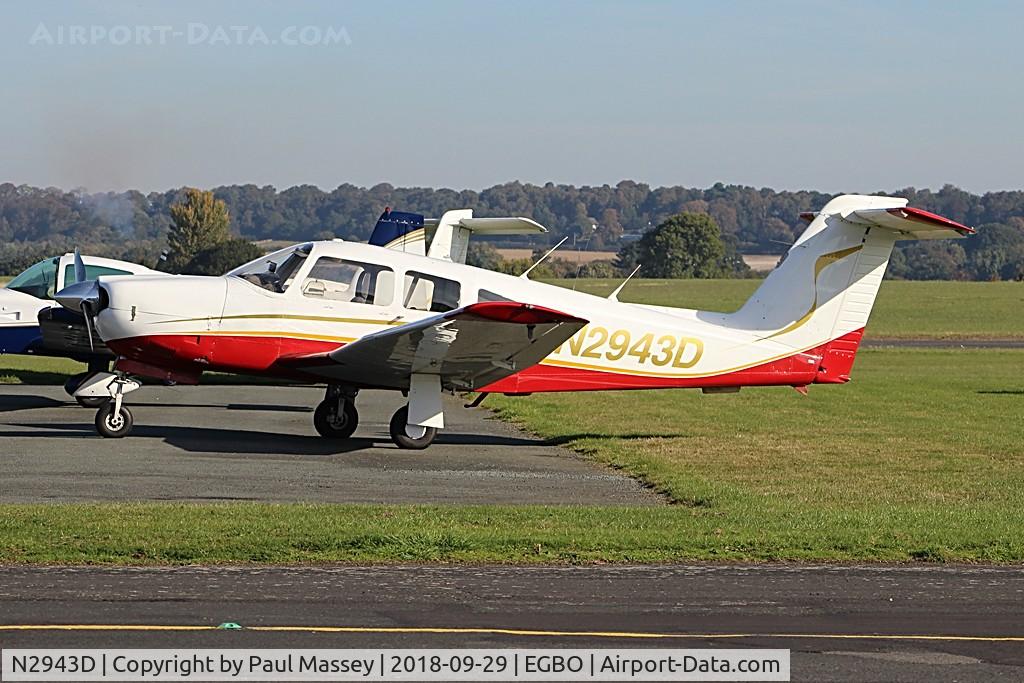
[{"x1": 57, "y1": 195, "x2": 973, "y2": 449}]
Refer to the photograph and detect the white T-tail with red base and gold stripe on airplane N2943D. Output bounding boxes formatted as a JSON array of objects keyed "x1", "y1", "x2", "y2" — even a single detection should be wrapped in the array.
[{"x1": 726, "y1": 195, "x2": 974, "y2": 383}]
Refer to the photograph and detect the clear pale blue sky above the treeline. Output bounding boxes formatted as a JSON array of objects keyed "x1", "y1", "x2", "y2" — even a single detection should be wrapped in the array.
[{"x1": 0, "y1": 0, "x2": 1024, "y2": 191}]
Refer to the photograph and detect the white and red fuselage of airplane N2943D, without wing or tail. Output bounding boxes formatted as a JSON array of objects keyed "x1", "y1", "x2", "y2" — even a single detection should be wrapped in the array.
[{"x1": 97, "y1": 241, "x2": 860, "y2": 393}]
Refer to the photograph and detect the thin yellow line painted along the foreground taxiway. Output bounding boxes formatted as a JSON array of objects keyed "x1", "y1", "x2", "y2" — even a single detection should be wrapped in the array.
[{"x1": 0, "y1": 624, "x2": 1024, "y2": 643}]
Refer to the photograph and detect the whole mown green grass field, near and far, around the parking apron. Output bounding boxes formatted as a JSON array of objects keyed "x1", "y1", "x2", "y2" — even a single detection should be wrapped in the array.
[{"x1": 0, "y1": 281, "x2": 1024, "y2": 564}]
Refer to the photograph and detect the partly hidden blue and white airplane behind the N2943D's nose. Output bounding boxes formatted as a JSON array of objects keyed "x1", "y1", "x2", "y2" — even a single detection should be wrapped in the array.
[{"x1": 0, "y1": 253, "x2": 156, "y2": 407}]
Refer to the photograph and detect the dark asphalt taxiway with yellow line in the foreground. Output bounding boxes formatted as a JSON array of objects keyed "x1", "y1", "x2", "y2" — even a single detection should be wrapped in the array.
[{"x1": 0, "y1": 565, "x2": 1024, "y2": 681}]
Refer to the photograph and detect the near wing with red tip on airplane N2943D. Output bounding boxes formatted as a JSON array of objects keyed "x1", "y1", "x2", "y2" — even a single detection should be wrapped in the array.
[{"x1": 288, "y1": 301, "x2": 588, "y2": 390}]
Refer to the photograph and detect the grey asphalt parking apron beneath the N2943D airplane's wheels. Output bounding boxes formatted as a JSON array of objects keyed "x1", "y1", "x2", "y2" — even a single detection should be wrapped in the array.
[{"x1": 0, "y1": 385, "x2": 665, "y2": 505}]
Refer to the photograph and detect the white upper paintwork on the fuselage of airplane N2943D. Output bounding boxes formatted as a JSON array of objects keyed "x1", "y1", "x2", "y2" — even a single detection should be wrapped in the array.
[{"x1": 97, "y1": 236, "x2": 847, "y2": 377}]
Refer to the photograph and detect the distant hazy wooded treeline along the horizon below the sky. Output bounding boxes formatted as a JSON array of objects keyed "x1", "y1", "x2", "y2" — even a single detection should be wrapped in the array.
[{"x1": 0, "y1": 180, "x2": 1024, "y2": 280}]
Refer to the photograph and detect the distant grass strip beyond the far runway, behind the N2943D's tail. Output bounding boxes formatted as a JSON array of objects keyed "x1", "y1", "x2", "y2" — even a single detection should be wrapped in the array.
[{"x1": 555, "y1": 280, "x2": 1024, "y2": 339}]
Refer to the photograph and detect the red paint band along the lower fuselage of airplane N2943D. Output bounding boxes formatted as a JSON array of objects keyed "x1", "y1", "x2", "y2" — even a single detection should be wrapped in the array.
[{"x1": 106, "y1": 330, "x2": 863, "y2": 393}]
